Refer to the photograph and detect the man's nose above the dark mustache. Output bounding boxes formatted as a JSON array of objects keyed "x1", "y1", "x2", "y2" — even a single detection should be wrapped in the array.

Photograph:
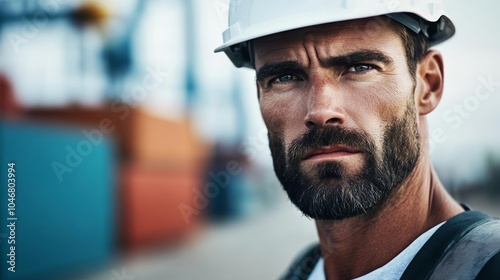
[{"x1": 304, "y1": 81, "x2": 345, "y2": 129}]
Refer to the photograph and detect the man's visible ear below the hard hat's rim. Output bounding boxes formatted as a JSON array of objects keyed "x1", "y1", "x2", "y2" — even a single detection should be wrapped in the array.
[{"x1": 415, "y1": 50, "x2": 444, "y2": 115}]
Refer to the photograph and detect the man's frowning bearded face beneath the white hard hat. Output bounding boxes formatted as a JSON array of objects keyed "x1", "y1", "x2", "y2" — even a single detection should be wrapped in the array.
[{"x1": 254, "y1": 19, "x2": 420, "y2": 220}]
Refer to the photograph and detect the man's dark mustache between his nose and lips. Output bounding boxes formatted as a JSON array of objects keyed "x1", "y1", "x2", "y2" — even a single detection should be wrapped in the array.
[{"x1": 288, "y1": 126, "x2": 375, "y2": 161}]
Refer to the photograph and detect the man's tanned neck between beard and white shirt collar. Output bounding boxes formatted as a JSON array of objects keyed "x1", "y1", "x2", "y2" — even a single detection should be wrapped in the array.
[{"x1": 316, "y1": 149, "x2": 463, "y2": 280}]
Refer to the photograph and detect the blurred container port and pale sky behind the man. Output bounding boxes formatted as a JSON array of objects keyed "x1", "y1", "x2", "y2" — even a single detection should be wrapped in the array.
[{"x1": 0, "y1": 0, "x2": 500, "y2": 280}]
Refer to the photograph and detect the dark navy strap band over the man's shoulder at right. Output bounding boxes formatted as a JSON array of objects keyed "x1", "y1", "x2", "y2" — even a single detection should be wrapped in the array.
[{"x1": 401, "y1": 211, "x2": 493, "y2": 280}]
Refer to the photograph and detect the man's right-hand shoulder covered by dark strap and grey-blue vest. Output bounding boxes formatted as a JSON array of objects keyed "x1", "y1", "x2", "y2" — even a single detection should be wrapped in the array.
[{"x1": 402, "y1": 211, "x2": 500, "y2": 279}]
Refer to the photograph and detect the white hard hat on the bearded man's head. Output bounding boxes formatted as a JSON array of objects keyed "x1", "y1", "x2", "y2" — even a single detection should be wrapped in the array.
[{"x1": 215, "y1": 0, "x2": 455, "y2": 68}]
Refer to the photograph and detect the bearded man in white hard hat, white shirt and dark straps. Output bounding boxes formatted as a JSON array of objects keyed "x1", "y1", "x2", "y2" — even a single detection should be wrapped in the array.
[{"x1": 216, "y1": 0, "x2": 500, "y2": 280}]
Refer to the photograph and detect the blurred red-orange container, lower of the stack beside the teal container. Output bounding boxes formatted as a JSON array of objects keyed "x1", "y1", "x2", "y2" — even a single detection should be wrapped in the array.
[{"x1": 121, "y1": 165, "x2": 202, "y2": 249}]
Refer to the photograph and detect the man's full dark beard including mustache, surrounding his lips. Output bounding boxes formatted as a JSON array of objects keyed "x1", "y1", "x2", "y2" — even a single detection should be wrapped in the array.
[{"x1": 269, "y1": 104, "x2": 420, "y2": 220}]
